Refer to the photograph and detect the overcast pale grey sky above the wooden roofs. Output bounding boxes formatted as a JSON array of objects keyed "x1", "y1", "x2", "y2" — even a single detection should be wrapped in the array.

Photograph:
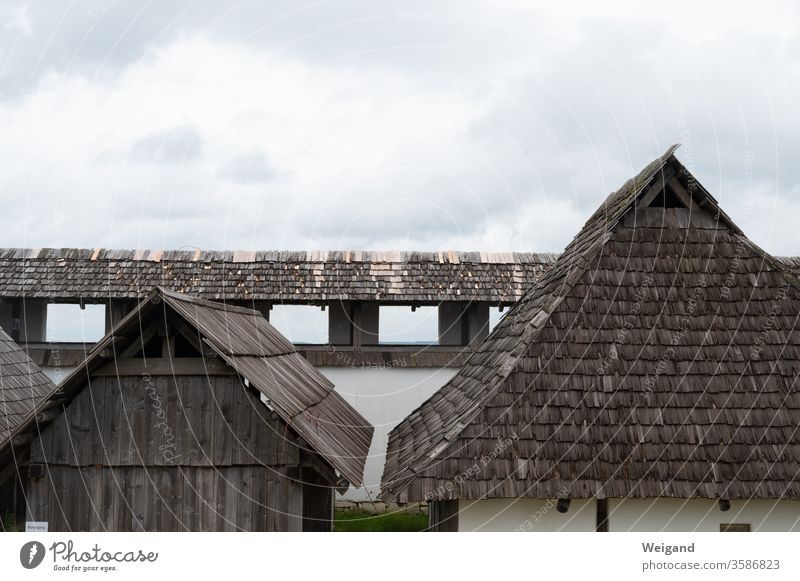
[{"x1": 0, "y1": 0, "x2": 800, "y2": 255}]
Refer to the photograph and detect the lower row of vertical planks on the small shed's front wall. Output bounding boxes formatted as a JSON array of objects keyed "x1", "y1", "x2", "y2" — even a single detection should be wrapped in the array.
[{"x1": 27, "y1": 465, "x2": 306, "y2": 531}]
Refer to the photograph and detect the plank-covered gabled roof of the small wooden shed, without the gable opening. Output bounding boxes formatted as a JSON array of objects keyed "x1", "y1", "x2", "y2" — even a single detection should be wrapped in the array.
[{"x1": 0, "y1": 288, "x2": 373, "y2": 486}]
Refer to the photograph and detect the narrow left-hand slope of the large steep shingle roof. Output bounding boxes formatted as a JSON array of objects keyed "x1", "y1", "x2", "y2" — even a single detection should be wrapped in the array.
[{"x1": 380, "y1": 144, "x2": 678, "y2": 500}]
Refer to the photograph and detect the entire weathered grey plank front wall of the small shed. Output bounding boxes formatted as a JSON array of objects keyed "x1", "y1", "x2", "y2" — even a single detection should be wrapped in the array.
[{"x1": 27, "y1": 375, "x2": 324, "y2": 531}]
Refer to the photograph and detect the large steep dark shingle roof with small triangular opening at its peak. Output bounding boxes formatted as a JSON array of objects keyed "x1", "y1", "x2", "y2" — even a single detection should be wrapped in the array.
[{"x1": 382, "y1": 146, "x2": 800, "y2": 500}]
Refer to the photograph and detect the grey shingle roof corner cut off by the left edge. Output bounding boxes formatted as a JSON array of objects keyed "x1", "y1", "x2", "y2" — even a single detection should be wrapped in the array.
[{"x1": 0, "y1": 329, "x2": 57, "y2": 447}]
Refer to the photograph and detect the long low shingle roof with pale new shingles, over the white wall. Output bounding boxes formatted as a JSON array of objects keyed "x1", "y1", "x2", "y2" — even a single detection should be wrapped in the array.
[{"x1": 0, "y1": 248, "x2": 554, "y2": 303}]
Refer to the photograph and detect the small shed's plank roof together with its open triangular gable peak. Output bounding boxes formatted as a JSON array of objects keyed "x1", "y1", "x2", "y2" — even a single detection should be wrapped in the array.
[{"x1": 3, "y1": 289, "x2": 373, "y2": 488}]
